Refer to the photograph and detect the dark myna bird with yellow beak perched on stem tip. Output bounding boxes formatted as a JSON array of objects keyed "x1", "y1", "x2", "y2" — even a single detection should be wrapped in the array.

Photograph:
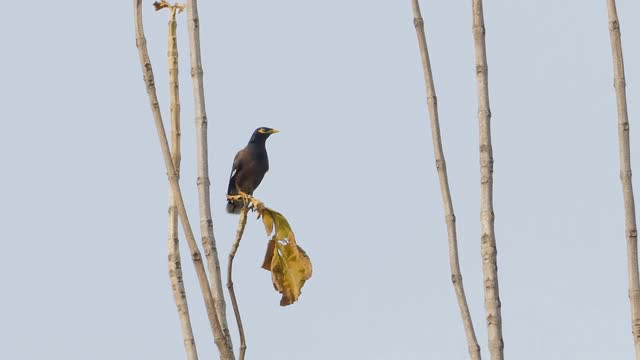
[{"x1": 227, "y1": 127, "x2": 278, "y2": 214}]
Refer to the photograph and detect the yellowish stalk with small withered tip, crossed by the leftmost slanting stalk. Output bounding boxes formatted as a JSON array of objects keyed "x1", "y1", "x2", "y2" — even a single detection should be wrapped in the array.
[{"x1": 161, "y1": 5, "x2": 198, "y2": 360}]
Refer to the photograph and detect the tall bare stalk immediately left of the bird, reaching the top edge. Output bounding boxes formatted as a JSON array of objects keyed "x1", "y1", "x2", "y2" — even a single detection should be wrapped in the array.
[{"x1": 187, "y1": 0, "x2": 233, "y2": 347}]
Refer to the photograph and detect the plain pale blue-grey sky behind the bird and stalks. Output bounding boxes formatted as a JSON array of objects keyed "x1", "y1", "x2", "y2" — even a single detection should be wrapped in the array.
[{"x1": 0, "y1": 0, "x2": 640, "y2": 360}]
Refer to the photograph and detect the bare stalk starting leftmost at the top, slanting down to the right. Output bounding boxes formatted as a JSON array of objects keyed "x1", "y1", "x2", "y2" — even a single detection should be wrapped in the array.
[{"x1": 133, "y1": 0, "x2": 234, "y2": 360}]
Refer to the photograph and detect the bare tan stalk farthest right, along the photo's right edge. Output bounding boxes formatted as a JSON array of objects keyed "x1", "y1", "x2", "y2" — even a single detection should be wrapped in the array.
[{"x1": 607, "y1": 0, "x2": 640, "y2": 360}]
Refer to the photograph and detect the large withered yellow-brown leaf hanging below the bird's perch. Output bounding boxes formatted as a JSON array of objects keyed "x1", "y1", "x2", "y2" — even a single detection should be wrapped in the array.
[{"x1": 260, "y1": 207, "x2": 312, "y2": 306}]
